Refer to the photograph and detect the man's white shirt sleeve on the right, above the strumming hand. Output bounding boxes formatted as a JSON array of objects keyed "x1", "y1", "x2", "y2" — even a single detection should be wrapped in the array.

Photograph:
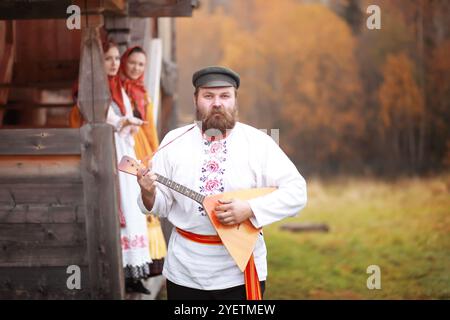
[{"x1": 249, "y1": 136, "x2": 307, "y2": 228}]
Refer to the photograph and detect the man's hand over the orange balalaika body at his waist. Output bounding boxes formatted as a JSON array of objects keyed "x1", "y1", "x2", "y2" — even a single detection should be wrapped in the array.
[{"x1": 214, "y1": 199, "x2": 253, "y2": 226}]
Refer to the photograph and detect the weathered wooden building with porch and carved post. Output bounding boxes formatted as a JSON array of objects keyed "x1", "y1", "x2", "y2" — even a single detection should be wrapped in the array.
[{"x1": 0, "y1": 0, "x2": 196, "y2": 299}]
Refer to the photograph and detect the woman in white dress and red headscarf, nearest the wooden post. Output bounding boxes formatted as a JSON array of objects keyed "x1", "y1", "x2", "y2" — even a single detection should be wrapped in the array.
[{"x1": 70, "y1": 42, "x2": 152, "y2": 294}]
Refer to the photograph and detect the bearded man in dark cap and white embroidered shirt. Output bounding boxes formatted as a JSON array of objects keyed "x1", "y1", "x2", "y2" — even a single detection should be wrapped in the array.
[{"x1": 138, "y1": 66, "x2": 307, "y2": 300}]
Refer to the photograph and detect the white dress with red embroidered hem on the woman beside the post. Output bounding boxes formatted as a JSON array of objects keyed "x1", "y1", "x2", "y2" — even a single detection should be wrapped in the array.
[{"x1": 106, "y1": 89, "x2": 152, "y2": 279}]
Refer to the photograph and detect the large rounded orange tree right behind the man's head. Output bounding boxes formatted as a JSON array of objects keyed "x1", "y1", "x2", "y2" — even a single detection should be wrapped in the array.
[{"x1": 223, "y1": 1, "x2": 364, "y2": 173}]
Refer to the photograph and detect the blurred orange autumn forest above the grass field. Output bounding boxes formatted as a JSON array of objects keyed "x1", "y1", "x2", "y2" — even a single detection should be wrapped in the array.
[{"x1": 176, "y1": 0, "x2": 450, "y2": 177}]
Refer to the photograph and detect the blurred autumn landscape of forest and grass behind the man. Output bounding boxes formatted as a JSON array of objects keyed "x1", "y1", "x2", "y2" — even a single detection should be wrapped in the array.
[{"x1": 170, "y1": 0, "x2": 450, "y2": 299}]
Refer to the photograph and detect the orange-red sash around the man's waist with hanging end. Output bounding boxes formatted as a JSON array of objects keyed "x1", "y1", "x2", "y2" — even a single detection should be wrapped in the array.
[{"x1": 176, "y1": 228, "x2": 262, "y2": 300}]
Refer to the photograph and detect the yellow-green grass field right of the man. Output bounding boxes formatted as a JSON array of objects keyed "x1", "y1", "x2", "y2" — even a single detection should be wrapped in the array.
[{"x1": 264, "y1": 175, "x2": 450, "y2": 299}]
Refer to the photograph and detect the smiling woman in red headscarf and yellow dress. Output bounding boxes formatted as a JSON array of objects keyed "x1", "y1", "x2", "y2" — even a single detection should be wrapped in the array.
[{"x1": 119, "y1": 47, "x2": 167, "y2": 276}]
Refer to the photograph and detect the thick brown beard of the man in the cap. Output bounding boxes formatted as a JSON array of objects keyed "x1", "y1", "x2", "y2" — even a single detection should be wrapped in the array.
[{"x1": 197, "y1": 106, "x2": 237, "y2": 136}]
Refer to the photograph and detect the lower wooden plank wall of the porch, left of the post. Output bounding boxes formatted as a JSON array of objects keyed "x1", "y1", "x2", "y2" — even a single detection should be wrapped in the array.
[{"x1": 0, "y1": 129, "x2": 91, "y2": 299}]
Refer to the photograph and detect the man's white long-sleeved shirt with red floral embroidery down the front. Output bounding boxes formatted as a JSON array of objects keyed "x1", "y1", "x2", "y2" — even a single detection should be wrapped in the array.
[{"x1": 137, "y1": 122, "x2": 306, "y2": 290}]
